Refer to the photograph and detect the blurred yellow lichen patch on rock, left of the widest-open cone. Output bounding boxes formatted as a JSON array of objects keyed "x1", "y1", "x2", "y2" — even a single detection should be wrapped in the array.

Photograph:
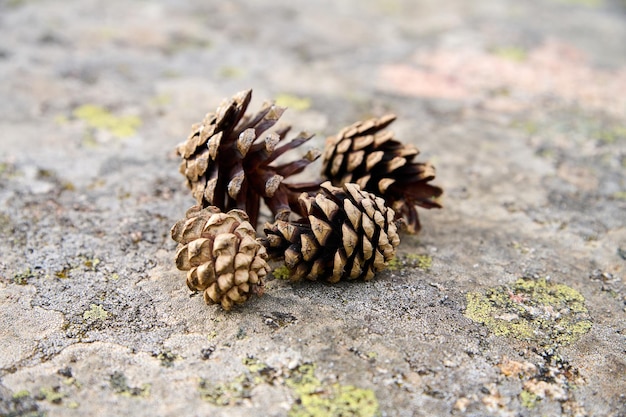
[{"x1": 73, "y1": 104, "x2": 142, "y2": 138}]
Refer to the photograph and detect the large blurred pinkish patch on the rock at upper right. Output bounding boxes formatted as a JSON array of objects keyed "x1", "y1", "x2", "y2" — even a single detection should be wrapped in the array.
[{"x1": 378, "y1": 41, "x2": 626, "y2": 115}]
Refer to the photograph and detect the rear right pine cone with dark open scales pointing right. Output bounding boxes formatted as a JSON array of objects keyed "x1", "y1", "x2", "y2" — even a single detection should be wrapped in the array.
[{"x1": 322, "y1": 115, "x2": 443, "y2": 233}]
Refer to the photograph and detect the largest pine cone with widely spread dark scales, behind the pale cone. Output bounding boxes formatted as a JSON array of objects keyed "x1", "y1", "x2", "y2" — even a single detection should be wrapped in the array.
[{"x1": 176, "y1": 90, "x2": 320, "y2": 227}]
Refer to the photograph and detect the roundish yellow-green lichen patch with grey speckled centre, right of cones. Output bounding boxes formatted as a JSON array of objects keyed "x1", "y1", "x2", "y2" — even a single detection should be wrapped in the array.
[{"x1": 465, "y1": 278, "x2": 592, "y2": 348}]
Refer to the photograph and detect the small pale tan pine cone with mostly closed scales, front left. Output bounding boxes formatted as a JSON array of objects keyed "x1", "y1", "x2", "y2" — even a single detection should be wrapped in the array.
[{"x1": 172, "y1": 206, "x2": 270, "y2": 310}]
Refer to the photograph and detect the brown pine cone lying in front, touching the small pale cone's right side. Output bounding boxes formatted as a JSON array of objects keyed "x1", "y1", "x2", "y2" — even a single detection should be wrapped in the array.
[{"x1": 262, "y1": 182, "x2": 400, "y2": 282}]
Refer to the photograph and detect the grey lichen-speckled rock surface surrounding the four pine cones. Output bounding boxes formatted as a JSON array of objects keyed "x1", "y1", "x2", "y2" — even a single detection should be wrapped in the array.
[{"x1": 0, "y1": 0, "x2": 626, "y2": 417}]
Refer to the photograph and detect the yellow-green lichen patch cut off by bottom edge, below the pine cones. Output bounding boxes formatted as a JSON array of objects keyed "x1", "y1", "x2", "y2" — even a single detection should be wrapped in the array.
[{"x1": 286, "y1": 364, "x2": 380, "y2": 417}]
